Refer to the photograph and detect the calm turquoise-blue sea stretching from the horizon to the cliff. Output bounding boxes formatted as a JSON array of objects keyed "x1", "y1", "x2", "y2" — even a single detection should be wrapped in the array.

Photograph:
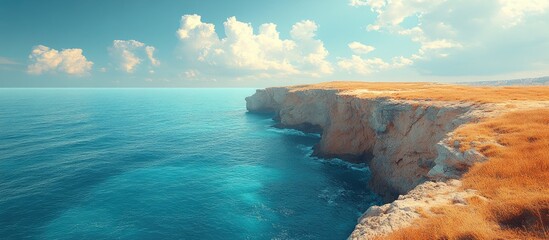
[{"x1": 0, "y1": 89, "x2": 380, "y2": 239}]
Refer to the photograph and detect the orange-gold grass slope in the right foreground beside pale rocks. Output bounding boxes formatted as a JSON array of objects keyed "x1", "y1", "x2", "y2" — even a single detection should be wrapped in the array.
[{"x1": 384, "y1": 109, "x2": 549, "y2": 239}]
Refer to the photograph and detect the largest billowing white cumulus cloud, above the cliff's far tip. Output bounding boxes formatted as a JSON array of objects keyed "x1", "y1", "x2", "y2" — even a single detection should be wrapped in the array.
[{"x1": 177, "y1": 15, "x2": 333, "y2": 77}]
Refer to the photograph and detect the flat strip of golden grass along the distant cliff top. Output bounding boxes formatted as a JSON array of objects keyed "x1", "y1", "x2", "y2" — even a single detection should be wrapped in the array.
[{"x1": 292, "y1": 82, "x2": 549, "y2": 103}]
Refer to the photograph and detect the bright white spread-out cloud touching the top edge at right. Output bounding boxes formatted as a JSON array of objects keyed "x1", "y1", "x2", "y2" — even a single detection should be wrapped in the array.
[{"x1": 360, "y1": 0, "x2": 549, "y2": 49}]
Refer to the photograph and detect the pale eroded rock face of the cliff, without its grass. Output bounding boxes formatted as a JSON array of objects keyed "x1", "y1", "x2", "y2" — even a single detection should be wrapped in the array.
[{"x1": 246, "y1": 88, "x2": 485, "y2": 238}]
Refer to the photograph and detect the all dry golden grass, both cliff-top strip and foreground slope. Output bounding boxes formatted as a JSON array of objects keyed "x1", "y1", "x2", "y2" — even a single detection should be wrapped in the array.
[{"x1": 286, "y1": 82, "x2": 549, "y2": 239}]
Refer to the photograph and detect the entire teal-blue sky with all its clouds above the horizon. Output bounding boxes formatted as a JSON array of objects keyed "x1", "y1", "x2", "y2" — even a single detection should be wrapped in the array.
[{"x1": 0, "y1": 0, "x2": 549, "y2": 87}]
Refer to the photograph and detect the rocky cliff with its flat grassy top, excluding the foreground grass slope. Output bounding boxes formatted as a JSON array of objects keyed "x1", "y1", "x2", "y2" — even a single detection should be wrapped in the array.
[{"x1": 246, "y1": 82, "x2": 549, "y2": 239}]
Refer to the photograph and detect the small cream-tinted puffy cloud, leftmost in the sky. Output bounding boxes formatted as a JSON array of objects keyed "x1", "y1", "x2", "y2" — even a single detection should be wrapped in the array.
[{"x1": 27, "y1": 45, "x2": 93, "y2": 75}]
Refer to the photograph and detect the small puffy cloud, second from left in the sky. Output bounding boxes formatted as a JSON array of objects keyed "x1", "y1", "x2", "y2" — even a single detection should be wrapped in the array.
[{"x1": 109, "y1": 40, "x2": 160, "y2": 73}]
